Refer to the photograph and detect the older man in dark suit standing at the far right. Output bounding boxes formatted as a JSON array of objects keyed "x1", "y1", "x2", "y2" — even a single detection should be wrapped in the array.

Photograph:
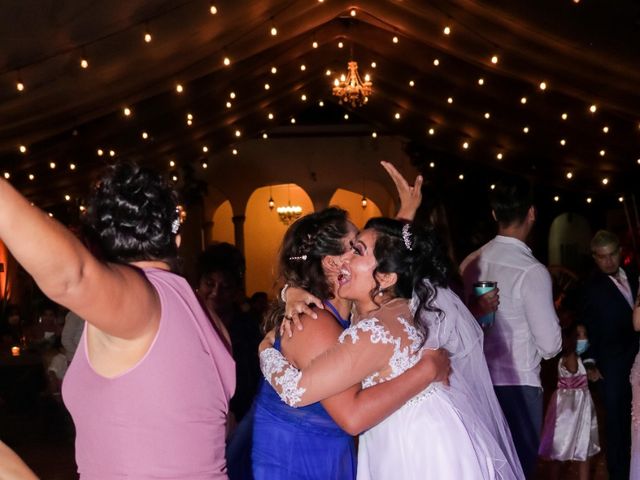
[{"x1": 583, "y1": 230, "x2": 638, "y2": 480}]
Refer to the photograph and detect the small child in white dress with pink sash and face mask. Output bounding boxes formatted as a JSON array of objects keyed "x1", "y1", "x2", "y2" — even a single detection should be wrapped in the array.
[{"x1": 538, "y1": 323, "x2": 600, "y2": 480}]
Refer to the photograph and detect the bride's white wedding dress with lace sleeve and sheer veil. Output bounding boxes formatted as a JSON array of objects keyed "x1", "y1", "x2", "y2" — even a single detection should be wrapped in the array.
[{"x1": 261, "y1": 289, "x2": 524, "y2": 480}]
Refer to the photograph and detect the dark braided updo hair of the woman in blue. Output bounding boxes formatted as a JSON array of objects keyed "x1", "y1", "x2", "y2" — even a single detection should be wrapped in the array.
[{"x1": 267, "y1": 207, "x2": 356, "y2": 327}]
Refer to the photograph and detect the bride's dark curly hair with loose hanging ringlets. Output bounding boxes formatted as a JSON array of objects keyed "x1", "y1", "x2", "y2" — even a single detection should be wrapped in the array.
[{"x1": 364, "y1": 217, "x2": 452, "y2": 343}]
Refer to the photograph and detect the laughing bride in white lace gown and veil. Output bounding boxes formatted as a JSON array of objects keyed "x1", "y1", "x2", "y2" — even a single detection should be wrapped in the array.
[{"x1": 260, "y1": 219, "x2": 524, "y2": 480}]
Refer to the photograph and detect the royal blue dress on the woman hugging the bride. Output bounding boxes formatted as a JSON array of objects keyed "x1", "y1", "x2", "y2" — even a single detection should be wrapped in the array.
[{"x1": 251, "y1": 302, "x2": 357, "y2": 480}]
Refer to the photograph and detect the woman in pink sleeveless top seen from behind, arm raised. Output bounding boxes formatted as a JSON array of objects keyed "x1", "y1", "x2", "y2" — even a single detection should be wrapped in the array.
[{"x1": 0, "y1": 164, "x2": 235, "y2": 480}]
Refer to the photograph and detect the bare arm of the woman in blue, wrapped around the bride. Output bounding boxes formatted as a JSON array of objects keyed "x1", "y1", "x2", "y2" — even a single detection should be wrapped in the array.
[{"x1": 282, "y1": 311, "x2": 449, "y2": 435}]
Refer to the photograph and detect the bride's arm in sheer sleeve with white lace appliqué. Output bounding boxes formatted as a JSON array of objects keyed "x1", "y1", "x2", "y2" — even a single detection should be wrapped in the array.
[{"x1": 260, "y1": 320, "x2": 393, "y2": 407}]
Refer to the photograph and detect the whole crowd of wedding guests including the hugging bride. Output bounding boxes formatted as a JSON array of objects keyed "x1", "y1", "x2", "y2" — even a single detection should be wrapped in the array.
[{"x1": 0, "y1": 164, "x2": 640, "y2": 480}]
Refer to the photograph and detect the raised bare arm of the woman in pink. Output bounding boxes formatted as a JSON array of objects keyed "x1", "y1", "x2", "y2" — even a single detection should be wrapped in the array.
[{"x1": 0, "y1": 180, "x2": 160, "y2": 339}]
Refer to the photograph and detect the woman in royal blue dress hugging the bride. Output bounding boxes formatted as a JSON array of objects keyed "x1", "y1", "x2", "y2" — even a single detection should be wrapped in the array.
[{"x1": 252, "y1": 208, "x2": 448, "y2": 480}]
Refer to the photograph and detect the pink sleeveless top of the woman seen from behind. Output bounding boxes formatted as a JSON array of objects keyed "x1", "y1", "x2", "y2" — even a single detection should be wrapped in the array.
[{"x1": 62, "y1": 270, "x2": 235, "y2": 480}]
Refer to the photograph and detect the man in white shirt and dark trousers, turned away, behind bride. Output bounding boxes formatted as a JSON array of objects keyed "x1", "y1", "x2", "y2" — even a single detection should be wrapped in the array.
[{"x1": 460, "y1": 180, "x2": 562, "y2": 478}]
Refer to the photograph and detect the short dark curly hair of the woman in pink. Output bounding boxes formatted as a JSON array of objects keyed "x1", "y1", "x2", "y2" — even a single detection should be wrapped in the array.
[{"x1": 87, "y1": 162, "x2": 179, "y2": 263}]
